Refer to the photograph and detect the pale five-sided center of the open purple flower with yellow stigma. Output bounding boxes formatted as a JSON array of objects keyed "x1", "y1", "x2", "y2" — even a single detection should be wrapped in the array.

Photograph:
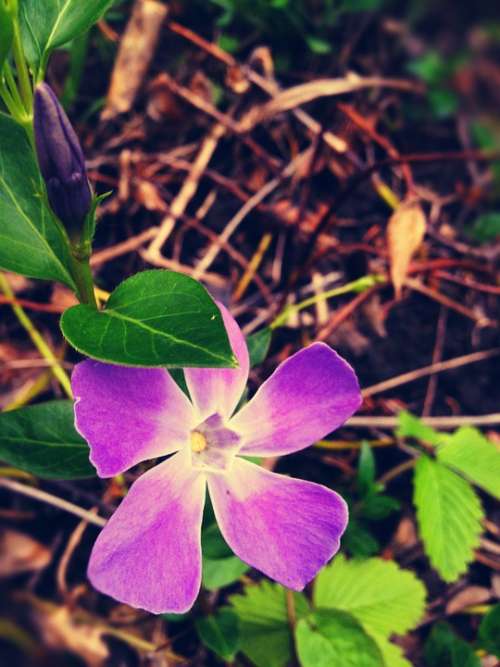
[{"x1": 190, "y1": 413, "x2": 240, "y2": 473}]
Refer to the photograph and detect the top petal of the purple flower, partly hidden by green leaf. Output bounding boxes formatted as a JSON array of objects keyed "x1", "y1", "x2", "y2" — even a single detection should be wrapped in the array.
[{"x1": 184, "y1": 303, "x2": 249, "y2": 419}]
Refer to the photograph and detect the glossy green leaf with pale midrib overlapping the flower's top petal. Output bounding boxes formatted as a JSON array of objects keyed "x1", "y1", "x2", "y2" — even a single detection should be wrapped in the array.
[{"x1": 61, "y1": 270, "x2": 237, "y2": 368}]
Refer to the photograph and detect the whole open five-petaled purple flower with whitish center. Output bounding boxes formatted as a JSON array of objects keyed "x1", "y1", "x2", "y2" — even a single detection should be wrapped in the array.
[{"x1": 72, "y1": 306, "x2": 361, "y2": 613}]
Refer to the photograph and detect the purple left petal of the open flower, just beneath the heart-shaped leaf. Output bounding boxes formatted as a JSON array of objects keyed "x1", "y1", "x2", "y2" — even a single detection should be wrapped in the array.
[{"x1": 71, "y1": 360, "x2": 195, "y2": 477}]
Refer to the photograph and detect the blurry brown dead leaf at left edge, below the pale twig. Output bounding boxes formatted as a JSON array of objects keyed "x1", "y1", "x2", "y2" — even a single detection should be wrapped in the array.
[{"x1": 0, "y1": 529, "x2": 52, "y2": 577}]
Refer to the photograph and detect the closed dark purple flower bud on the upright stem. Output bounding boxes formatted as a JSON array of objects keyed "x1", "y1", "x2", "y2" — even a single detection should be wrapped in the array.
[{"x1": 34, "y1": 83, "x2": 92, "y2": 233}]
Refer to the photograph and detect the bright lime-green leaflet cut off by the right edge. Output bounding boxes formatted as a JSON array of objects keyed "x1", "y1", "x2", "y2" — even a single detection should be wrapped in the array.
[{"x1": 437, "y1": 426, "x2": 500, "y2": 500}]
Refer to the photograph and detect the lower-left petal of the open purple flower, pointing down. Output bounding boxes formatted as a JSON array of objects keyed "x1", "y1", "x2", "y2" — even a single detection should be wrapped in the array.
[{"x1": 88, "y1": 452, "x2": 205, "y2": 614}]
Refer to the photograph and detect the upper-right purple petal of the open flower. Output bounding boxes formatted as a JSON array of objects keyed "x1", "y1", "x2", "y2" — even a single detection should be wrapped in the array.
[{"x1": 229, "y1": 343, "x2": 361, "y2": 456}]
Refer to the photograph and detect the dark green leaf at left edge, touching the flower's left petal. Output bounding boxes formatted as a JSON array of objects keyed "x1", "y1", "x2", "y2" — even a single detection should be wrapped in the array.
[{"x1": 0, "y1": 401, "x2": 96, "y2": 479}]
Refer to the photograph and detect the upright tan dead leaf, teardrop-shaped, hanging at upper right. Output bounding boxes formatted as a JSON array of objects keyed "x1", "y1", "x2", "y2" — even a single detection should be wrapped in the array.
[{"x1": 387, "y1": 197, "x2": 426, "y2": 298}]
